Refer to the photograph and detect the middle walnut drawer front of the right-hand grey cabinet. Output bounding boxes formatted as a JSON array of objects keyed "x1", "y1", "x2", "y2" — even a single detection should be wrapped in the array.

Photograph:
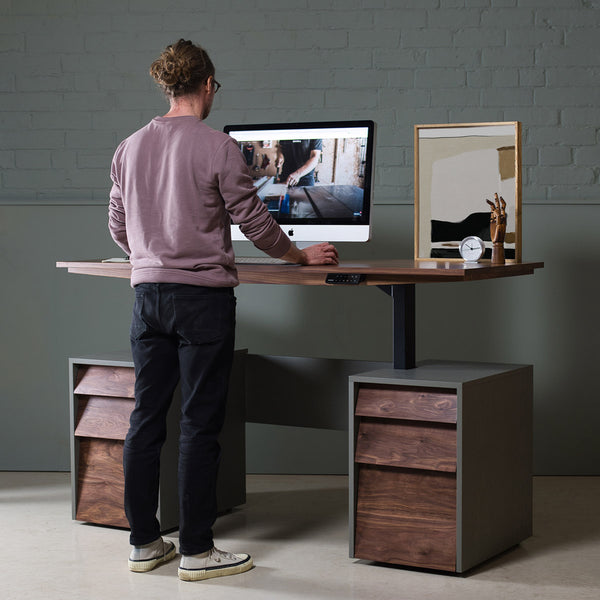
[{"x1": 355, "y1": 418, "x2": 456, "y2": 472}]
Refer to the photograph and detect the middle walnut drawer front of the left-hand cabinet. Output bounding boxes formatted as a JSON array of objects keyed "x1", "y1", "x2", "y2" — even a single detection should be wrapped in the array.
[{"x1": 75, "y1": 396, "x2": 135, "y2": 440}]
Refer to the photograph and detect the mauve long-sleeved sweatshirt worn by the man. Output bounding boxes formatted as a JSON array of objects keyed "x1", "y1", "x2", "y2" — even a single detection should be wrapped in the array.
[{"x1": 108, "y1": 116, "x2": 291, "y2": 287}]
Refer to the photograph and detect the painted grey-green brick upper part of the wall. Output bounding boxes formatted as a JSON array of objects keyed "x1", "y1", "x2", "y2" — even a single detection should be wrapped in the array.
[{"x1": 0, "y1": 0, "x2": 600, "y2": 204}]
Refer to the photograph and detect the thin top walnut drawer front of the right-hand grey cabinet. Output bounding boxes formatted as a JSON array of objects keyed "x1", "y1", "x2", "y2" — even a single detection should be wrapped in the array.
[{"x1": 356, "y1": 383, "x2": 456, "y2": 423}]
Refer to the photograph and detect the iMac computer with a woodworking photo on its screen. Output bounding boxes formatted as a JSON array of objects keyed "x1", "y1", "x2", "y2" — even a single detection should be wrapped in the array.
[{"x1": 224, "y1": 121, "x2": 375, "y2": 242}]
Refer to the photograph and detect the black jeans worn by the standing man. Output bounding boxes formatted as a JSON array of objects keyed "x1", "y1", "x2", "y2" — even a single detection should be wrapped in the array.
[{"x1": 123, "y1": 283, "x2": 236, "y2": 554}]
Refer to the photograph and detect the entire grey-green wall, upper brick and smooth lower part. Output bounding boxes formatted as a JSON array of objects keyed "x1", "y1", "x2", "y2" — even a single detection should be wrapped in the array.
[{"x1": 0, "y1": 0, "x2": 600, "y2": 474}]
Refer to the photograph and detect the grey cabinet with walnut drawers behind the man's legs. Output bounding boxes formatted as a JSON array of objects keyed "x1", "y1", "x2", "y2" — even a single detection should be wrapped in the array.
[{"x1": 69, "y1": 350, "x2": 246, "y2": 531}]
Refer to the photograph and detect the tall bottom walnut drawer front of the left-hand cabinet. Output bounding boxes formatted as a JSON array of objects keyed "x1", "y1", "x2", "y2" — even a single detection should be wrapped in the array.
[{"x1": 75, "y1": 438, "x2": 129, "y2": 527}]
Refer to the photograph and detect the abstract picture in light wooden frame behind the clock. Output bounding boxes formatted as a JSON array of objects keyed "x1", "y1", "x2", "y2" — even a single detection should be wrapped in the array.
[{"x1": 414, "y1": 121, "x2": 522, "y2": 263}]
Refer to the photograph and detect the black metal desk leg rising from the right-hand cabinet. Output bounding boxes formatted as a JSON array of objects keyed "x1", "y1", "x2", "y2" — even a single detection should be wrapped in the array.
[{"x1": 379, "y1": 283, "x2": 416, "y2": 369}]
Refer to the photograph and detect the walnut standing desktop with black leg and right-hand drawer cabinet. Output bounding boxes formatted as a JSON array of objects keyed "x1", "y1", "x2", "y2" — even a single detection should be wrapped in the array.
[{"x1": 57, "y1": 260, "x2": 544, "y2": 572}]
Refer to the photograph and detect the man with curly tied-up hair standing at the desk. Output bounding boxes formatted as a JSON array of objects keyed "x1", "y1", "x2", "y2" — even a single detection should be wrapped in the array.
[{"x1": 109, "y1": 40, "x2": 338, "y2": 581}]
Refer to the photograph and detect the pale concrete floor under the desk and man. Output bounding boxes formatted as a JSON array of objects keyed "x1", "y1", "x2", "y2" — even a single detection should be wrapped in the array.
[{"x1": 0, "y1": 472, "x2": 600, "y2": 600}]
